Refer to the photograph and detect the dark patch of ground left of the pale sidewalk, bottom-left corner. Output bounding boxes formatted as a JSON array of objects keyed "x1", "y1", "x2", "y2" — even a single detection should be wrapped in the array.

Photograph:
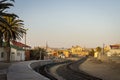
[{"x1": 0, "y1": 62, "x2": 11, "y2": 80}]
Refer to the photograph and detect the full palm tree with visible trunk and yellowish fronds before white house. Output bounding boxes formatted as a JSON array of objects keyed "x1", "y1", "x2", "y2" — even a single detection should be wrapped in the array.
[{"x1": 2, "y1": 16, "x2": 26, "y2": 62}]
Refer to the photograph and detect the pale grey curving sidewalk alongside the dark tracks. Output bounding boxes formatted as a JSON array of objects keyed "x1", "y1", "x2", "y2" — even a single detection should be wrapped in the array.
[{"x1": 7, "y1": 60, "x2": 51, "y2": 80}]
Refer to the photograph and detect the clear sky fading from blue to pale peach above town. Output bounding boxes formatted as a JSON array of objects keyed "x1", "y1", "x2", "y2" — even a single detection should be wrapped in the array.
[{"x1": 10, "y1": 0, "x2": 120, "y2": 48}]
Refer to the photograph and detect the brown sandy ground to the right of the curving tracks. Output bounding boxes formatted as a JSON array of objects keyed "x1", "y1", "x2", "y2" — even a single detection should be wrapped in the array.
[{"x1": 79, "y1": 57, "x2": 120, "y2": 80}]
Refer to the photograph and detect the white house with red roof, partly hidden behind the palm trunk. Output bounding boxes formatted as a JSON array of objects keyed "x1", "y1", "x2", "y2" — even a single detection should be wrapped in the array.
[{"x1": 0, "y1": 41, "x2": 30, "y2": 61}]
